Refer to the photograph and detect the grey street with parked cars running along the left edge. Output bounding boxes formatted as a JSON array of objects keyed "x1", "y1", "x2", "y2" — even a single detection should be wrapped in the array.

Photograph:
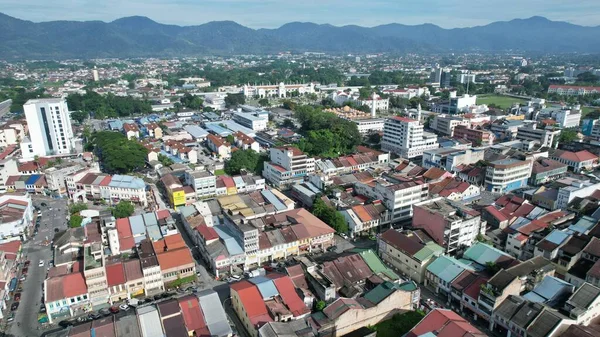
[{"x1": 10, "y1": 196, "x2": 67, "y2": 337}]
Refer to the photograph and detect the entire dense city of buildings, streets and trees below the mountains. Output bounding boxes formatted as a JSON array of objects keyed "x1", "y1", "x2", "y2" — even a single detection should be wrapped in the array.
[{"x1": 0, "y1": 7, "x2": 600, "y2": 337}]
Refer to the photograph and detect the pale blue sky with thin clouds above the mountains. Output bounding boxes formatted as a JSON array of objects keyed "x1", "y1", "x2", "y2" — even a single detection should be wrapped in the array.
[{"x1": 0, "y1": 0, "x2": 600, "y2": 28}]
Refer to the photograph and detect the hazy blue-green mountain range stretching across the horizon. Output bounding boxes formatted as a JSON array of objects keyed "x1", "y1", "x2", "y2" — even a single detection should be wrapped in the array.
[{"x1": 0, "y1": 13, "x2": 600, "y2": 60}]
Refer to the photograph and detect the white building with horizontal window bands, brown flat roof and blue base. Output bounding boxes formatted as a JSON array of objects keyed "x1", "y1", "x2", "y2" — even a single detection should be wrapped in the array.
[{"x1": 485, "y1": 158, "x2": 532, "y2": 193}]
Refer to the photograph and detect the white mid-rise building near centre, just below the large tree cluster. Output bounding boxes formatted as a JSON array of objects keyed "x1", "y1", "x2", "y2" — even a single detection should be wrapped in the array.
[{"x1": 263, "y1": 146, "x2": 315, "y2": 186}]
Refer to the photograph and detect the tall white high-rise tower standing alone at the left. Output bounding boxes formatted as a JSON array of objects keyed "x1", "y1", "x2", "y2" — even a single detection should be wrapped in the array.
[{"x1": 21, "y1": 98, "x2": 73, "y2": 159}]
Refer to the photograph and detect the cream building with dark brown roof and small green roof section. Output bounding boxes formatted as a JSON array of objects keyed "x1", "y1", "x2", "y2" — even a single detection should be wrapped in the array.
[{"x1": 377, "y1": 229, "x2": 445, "y2": 283}]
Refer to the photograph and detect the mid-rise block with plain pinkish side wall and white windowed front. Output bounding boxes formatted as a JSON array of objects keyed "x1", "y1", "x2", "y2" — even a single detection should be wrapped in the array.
[{"x1": 412, "y1": 197, "x2": 486, "y2": 253}]
